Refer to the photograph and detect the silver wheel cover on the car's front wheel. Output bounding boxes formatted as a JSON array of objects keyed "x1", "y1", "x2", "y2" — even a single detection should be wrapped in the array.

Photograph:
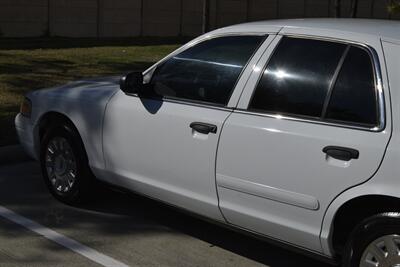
[{"x1": 45, "y1": 137, "x2": 77, "y2": 194}]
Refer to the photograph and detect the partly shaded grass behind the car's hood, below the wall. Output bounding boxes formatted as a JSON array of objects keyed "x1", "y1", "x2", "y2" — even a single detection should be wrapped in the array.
[{"x1": 0, "y1": 38, "x2": 186, "y2": 146}]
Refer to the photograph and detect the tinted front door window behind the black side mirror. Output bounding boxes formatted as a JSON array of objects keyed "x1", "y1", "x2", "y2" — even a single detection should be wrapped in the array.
[{"x1": 151, "y1": 36, "x2": 265, "y2": 105}]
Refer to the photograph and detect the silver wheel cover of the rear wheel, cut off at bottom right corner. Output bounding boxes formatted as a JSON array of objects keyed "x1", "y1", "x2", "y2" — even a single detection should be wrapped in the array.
[{"x1": 360, "y1": 234, "x2": 400, "y2": 267}]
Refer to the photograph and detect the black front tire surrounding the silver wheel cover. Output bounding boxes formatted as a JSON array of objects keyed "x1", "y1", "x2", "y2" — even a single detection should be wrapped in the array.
[{"x1": 40, "y1": 123, "x2": 95, "y2": 205}]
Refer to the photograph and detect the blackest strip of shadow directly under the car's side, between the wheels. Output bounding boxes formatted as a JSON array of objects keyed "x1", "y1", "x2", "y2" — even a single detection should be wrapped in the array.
[{"x1": 77, "y1": 185, "x2": 332, "y2": 267}]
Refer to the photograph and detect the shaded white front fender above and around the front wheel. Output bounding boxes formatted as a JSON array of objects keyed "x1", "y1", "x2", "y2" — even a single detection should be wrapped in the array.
[{"x1": 28, "y1": 80, "x2": 119, "y2": 169}]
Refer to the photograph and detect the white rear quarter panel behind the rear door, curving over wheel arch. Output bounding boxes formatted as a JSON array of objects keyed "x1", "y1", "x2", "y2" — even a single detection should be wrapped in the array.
[{"x1": 321, "y1": 39, "x2": 400, "y2": 255}]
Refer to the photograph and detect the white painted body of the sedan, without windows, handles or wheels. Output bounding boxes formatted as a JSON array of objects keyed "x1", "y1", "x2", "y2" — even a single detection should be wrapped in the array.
[{"x1": 16, "y1": 19, "x2": 400, "y2": 262}]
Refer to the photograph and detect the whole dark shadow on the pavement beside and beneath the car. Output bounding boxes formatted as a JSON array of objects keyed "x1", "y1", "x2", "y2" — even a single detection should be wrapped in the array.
[{"x1": 0, "y1": 162, "x2": 330, "y2": 267}]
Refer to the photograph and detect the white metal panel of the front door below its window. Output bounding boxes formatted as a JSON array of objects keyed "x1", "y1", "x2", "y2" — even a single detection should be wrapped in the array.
[{"x1": 104, "y1": 92, "x2": 230, "y2": 221}]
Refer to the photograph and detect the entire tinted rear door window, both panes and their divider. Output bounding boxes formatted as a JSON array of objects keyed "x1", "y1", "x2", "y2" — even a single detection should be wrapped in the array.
[{"x1": 248, "y1": 37, "x2": 379, "y2": 127}]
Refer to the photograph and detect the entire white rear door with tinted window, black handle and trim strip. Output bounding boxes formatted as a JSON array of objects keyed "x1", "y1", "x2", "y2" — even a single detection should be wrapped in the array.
[{"x1": 216, "y1": 36, "x2": 390, "y2": 251}]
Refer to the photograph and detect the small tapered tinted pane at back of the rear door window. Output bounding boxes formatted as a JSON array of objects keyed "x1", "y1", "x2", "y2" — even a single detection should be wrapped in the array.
[{"x1": 326, "y1": 47, "x2": 378, "y2": 125}]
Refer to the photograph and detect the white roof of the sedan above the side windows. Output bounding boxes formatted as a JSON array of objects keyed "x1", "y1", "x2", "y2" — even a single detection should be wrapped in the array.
[{"x1": 220, "y1": 18, "x2": 400, "y2": 40}]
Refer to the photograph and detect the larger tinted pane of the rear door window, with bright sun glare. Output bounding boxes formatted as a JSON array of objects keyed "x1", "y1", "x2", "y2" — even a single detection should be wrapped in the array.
[{"x1": 249, "y1": 38, "x2": 346, "y2": 117}]
